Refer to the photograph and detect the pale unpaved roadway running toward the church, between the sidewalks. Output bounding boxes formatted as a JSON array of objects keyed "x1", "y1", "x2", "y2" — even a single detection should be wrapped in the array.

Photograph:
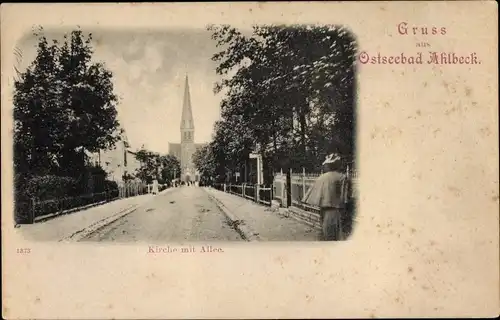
[{"x1": 82, "y1": 187, "x2": 242, "y2": 243}]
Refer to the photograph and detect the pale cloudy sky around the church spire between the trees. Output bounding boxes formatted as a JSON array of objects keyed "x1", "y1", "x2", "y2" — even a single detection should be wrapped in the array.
[{"x1": 18, "y1": 29, "x2": 226, "y2": 153}]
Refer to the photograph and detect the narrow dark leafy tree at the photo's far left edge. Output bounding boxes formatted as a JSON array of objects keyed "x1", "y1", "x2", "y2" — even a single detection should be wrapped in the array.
[{"x1": 13, "y1": 31, "x2": 61, "y2": 174}]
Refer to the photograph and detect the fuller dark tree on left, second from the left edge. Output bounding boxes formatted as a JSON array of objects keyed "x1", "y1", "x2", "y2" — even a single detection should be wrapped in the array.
[{"x1": 59, "y1": 30, "x2": 120, "y2": 178}]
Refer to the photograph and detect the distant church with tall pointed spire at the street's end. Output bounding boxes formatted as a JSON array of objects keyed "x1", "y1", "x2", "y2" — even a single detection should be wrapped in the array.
[{"x1": 168, "y1": 75, "x2": 205, "y2": 181}]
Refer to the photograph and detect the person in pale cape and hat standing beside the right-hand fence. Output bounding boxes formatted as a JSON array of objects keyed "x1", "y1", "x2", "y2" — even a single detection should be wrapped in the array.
[{"x1": 302, "y1": 154, "x2": 348, "y2": 241}]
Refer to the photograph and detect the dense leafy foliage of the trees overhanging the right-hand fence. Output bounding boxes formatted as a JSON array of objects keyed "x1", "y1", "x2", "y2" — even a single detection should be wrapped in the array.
[{"x1": 205, "y1": 25, "x2": 356, "y2": 180}]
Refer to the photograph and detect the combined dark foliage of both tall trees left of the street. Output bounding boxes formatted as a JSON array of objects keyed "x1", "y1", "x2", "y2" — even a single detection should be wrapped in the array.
[{"x1": 14, "y1": 26, "x2": 120, "y2": 180}]
